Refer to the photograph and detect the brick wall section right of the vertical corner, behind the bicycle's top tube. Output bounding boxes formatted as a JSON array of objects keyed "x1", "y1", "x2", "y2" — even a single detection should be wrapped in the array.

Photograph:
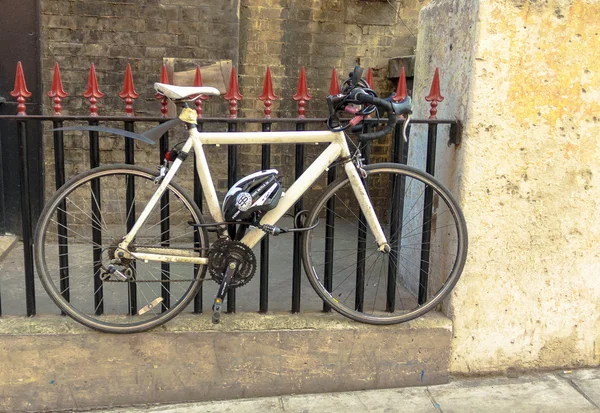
[{"x1": 234, "y1": 0, "x2": 425, "y2": 203}]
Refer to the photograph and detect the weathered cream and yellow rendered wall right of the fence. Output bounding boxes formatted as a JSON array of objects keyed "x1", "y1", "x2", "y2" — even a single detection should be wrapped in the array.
[{"x1": 415, "y1": 0, "x2": 600, "y2": 374}]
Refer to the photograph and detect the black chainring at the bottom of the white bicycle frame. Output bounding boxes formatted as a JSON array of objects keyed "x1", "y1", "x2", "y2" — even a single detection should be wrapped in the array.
[{"x1": 208, "y1": 238, "x2": 256, "y2": 288}]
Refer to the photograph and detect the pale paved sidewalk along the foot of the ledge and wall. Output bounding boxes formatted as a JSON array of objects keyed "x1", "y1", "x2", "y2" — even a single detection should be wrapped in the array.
[{"x1": 86, "y1": 368, "x2": 600, "y2": 413}]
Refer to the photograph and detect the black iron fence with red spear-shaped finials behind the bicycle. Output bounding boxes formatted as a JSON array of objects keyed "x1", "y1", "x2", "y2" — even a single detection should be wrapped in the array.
[{"x1": 0, "y1": 63, "x2": 460, "y2": 316}]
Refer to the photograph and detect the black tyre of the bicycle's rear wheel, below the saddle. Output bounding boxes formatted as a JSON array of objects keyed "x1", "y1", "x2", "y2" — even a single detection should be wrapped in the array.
[{"x1": 34, "y1": 164, "x2": 208, "y2": 334}]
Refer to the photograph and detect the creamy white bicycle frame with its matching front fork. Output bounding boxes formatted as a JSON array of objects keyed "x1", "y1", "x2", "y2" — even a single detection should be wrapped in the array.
[{"x1": 119, "y1": 116, "x2": 388, "y2": 264}]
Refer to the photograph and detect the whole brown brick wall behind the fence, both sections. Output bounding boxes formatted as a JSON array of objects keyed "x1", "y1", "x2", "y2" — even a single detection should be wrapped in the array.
[{"x1": 42, "y1": 0, "x2": 424, "y2": 209}]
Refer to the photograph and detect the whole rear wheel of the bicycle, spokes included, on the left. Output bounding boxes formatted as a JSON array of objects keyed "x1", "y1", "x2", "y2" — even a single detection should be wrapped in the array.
[{"x1": 35, "y1": 165, "x2": 208, "y2": 333}]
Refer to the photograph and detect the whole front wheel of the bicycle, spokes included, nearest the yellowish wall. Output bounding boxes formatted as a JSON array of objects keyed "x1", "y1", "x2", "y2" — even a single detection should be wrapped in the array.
[{"x1": 303, "y1": 163, "x2": 467, "y2": 324}]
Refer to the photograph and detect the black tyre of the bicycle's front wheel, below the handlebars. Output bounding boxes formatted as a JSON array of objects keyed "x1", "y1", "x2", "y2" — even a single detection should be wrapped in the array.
[{"x1": 302, "y1": 163, "x2": 468, "y2": 325}]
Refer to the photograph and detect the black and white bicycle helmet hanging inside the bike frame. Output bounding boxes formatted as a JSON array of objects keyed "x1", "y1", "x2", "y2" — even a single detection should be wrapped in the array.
[{"x1": 223, "y1": 169, "x2": 283, "y2": 221}]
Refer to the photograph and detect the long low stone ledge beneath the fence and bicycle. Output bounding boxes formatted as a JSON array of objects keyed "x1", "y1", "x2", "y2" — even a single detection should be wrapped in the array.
[{"x1": 0, "y1": 313, "x2": 452, "y2": 411}]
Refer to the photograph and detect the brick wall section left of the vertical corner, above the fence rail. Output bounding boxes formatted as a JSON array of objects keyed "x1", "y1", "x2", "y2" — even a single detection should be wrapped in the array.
[{"x1": 42, "y1": 0, "x2": 239, "y2": 115}]
